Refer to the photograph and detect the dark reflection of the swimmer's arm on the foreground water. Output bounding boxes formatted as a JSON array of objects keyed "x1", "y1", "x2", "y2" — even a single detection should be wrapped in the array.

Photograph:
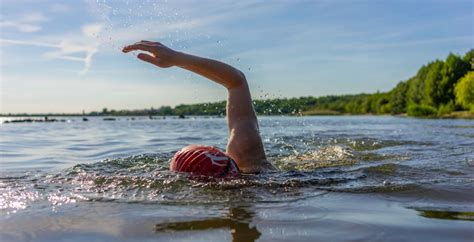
[{"x1": 155, "y1": 207, "x2": 261, "y2": 242}]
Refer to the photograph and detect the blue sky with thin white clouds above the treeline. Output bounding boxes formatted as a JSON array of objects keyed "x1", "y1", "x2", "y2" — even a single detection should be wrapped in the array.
[{"x1": 0, "y1": 0, "x2": 474, "y2": 114}]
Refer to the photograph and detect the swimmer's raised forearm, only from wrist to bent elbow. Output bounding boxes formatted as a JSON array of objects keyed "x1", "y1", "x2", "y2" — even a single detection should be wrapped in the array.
[{"x1": 175, "y1": 53, "x2": 246, "y2": 89}]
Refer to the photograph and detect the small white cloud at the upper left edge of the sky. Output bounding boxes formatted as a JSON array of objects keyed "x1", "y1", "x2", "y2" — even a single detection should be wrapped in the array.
[{"x1": 0, "y1": 12, "x2": 48, "y2": 33}]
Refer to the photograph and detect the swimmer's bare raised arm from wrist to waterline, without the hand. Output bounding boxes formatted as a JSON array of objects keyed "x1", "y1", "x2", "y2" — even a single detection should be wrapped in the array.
[{"x1": 175, "y1": 53, "x2": 271, "y2": 173}]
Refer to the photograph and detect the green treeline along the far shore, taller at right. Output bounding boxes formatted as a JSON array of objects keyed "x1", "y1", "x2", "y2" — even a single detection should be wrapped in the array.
[{"x1": 1, "y1": 49, "x2": 474, "y2": 117}]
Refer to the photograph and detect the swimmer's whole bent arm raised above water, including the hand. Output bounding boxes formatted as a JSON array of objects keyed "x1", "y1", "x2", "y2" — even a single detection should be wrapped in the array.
[{"x1": 123, "y1": 41, "x2": 274, "y2": 173}]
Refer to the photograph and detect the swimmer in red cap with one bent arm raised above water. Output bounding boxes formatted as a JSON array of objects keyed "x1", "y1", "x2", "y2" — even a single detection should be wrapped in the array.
[{"x1": 122, "y1": 40, "x2": 276, "y2": 177}]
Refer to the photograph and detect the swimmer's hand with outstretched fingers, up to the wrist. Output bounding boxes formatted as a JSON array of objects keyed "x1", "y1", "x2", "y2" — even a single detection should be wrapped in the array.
[{"x1": 122, "y1": 40, "x2": 179, "y2": 68}]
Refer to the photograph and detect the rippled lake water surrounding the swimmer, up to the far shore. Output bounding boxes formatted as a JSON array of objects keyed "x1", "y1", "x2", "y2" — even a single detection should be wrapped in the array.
[{"x1": 0, "y1": 116, "x2": 474, "y2": 241}]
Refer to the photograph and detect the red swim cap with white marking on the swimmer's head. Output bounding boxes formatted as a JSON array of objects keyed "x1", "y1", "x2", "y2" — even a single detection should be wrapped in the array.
[{"x1": 170, "y1": 145, "x2": 240, "y2": 177}]
